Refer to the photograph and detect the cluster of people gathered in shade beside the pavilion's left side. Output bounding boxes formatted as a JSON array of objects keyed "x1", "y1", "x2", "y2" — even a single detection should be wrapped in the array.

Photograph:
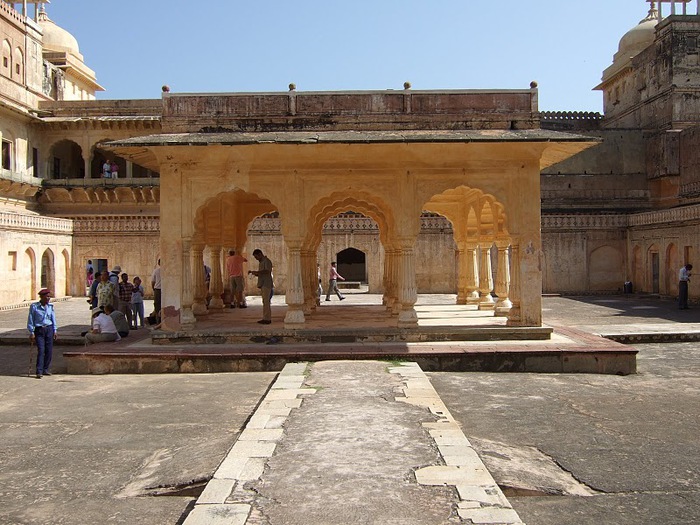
[{"x1": 85, "y1": 265, "x2": 146, "y2": 343}]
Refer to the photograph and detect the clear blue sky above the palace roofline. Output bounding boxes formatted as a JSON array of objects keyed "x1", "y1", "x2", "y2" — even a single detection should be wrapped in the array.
[{"x1": 46, "y1": 0, "x2": 672, "y2": 111}]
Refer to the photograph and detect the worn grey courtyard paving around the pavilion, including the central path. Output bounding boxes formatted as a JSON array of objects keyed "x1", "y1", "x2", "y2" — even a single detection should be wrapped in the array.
[{"x1": 0, "y1": 296, "x2": 700, "y2": 525}]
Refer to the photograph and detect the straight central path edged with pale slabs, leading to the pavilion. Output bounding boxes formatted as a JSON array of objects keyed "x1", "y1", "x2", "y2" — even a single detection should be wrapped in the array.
[{"x1": 184, "y1": 362, "x2": 522, "y2": 525}]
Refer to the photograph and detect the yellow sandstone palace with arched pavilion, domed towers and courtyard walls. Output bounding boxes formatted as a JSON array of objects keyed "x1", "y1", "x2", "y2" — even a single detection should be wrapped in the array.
[{"x1": 0, "y1": 0, "x2": 700, "y2": 326}]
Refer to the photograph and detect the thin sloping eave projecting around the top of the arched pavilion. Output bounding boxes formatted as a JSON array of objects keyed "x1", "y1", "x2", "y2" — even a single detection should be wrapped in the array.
[{"x1": 100, "y1": 129, "x2": 601, "y2": 172}]
